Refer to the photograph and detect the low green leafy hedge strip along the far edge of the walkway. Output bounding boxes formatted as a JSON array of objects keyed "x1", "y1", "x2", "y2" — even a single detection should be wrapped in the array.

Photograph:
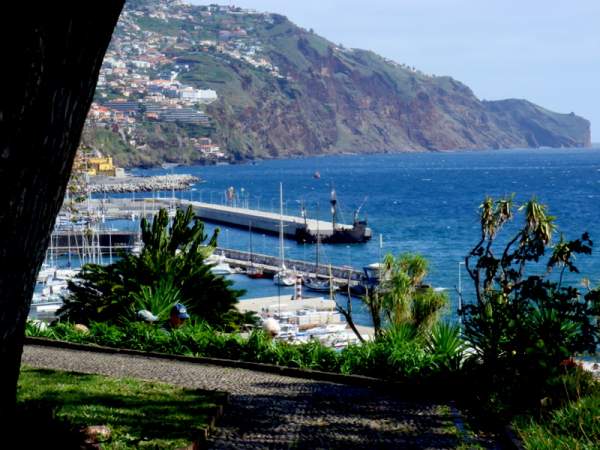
[{"x1": 28, "y1": 321, "x2": 466, "y2": 381}]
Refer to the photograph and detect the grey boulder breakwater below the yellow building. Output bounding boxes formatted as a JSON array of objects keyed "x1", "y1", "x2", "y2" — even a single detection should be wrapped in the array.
[{"x1": 88, "y1": 175, "x2": 200, "y2": 193}]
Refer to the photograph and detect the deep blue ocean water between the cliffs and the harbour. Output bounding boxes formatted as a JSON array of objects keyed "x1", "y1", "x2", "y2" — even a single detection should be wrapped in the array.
[{"x1": 127, "y1": 149, "x2": 600, "y2": 324}]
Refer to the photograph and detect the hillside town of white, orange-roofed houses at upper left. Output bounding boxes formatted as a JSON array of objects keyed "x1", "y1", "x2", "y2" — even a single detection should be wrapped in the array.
[{"x1": 86, "y1": 0, "x2": 284, "y2": 162}]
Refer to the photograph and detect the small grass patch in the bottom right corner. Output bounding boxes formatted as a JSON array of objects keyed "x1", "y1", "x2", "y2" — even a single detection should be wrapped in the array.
[{"x1": 515, "y1": 390, "x2": 600, "y2": 450}]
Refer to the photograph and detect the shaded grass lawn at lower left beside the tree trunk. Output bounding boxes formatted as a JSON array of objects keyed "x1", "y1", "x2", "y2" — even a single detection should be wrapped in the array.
[{"x1": 18, "y1": 367, "x2": 225, "y2": 449}]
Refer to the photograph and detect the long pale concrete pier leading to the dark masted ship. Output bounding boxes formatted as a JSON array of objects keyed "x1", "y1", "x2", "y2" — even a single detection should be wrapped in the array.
[{"x1": 79, "y1": 198, "x2": 371, "y2": 243}]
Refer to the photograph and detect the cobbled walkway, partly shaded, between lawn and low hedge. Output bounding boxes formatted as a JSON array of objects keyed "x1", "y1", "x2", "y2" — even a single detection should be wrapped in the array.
[{"x1": 23, "y1": 345, "x2": 496, "y2": 449}]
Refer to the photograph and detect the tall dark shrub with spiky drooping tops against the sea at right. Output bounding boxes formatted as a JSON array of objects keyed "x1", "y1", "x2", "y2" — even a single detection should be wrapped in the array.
[{"x1": 462, "y1": 198, "x2": 600, "y2": 413}]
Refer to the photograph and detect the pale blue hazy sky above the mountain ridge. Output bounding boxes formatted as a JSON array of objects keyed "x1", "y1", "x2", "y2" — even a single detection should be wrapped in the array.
[{"x1": 194, "y1": 0, "x2": 600, "y2": 142}]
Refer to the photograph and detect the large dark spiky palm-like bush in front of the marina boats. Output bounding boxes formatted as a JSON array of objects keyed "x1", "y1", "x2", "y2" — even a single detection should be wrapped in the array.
[{"x1": 58, "y1": 207, "x2": 246, "y2": 328}]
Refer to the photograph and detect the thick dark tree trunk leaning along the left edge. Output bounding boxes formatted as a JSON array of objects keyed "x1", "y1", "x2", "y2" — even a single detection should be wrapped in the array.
[{"x1": 0, "y1": 0, "x2": 124, "y2": 425}]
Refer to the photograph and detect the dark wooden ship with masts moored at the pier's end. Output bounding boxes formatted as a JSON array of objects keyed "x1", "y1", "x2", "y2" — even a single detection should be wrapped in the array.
[{"x1": 295, "y1": 188, "x2": 372, "y2": 244}]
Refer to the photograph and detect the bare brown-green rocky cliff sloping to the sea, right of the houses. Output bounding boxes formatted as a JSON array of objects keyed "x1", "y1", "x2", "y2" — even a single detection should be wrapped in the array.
[{"x1": 204, "y1": 17, "x2": 590, "y2": 156}]
